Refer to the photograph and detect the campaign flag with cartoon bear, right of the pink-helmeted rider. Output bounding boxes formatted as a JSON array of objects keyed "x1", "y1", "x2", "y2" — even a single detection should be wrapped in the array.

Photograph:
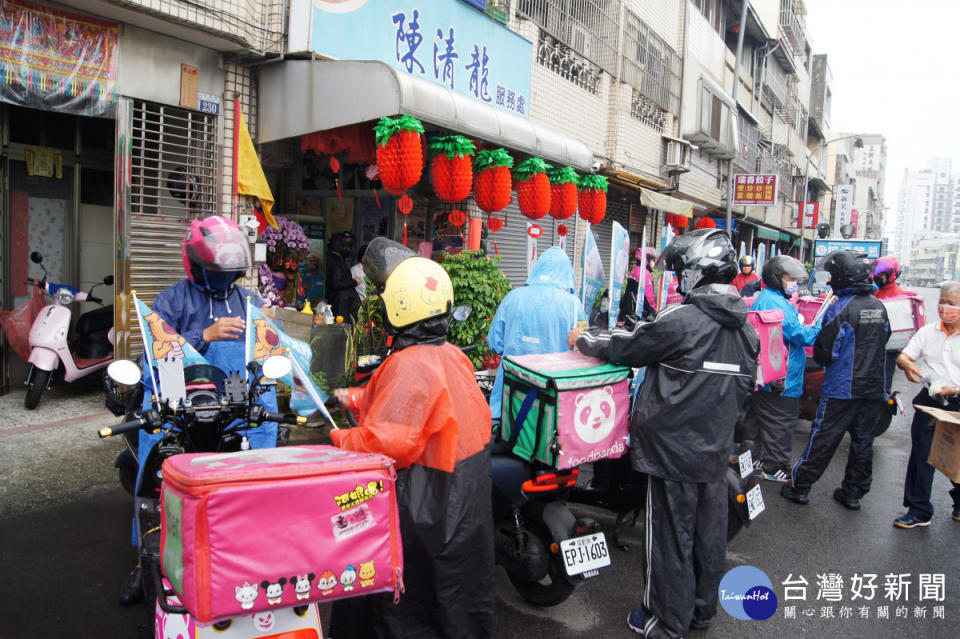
[{"x1": 246, "y1": 300, "x2": 333, "y2": 424}]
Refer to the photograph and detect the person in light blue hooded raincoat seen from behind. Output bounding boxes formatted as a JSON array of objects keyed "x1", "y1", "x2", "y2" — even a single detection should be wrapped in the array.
[{"x1": 487, "y1": 246, "x2": 587, "y2": 420}]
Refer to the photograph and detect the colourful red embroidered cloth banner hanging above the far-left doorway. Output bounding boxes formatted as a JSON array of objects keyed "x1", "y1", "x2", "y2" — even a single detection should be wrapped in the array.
[{"x1": 0, "y1": 0, "x2": 119, "y2": 116}]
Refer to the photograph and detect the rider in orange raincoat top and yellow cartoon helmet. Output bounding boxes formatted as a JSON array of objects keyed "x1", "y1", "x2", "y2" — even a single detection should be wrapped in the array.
[{"x1": 331, "y1": 238, "x2": 495, "y2": 639}]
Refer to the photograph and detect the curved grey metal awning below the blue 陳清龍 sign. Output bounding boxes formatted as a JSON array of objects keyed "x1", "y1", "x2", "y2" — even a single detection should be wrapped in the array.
[{"x1": 257, "y1": 60, "x2": 593, "y2": 171}]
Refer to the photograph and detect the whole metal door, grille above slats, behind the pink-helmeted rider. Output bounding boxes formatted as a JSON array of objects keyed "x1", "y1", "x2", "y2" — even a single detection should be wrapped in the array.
[{"x1": 114, "y1": 99, "x2": 218, "y2": 357}]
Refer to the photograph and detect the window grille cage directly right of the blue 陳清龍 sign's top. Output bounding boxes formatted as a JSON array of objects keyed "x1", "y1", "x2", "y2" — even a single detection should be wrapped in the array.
[{"x1": 517, "y1": 0, "x2": 620, "y2": 75}]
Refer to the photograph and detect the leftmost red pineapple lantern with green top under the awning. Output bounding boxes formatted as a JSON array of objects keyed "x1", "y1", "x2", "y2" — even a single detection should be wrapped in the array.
[{"x1": 373, "y1": 115, "x2": 423, "y2": 195}]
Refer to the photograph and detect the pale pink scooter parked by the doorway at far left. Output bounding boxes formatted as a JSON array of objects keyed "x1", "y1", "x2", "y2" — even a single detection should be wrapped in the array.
[{"x1": 23, "y1": 251, "x2": 113, "y2": 410}]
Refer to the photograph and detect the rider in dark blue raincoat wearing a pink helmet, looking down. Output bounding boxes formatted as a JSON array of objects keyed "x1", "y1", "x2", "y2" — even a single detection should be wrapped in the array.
[{"x1": 120, "y1": 216, "x2": 277, "y2": 605}]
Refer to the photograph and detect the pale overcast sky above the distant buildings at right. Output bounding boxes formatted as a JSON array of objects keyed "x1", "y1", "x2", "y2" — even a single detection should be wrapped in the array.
[{"x1": 804, "y1": 0, "x2": 960, "y2": 230}]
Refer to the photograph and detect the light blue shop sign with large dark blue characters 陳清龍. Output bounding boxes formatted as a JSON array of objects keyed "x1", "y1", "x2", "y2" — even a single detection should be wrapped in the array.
[{"x1": 310, "y1": 0, "x2": 533, "y2": 118}]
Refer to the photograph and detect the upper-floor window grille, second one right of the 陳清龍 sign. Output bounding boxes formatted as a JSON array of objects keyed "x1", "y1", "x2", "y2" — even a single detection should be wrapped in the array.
[{"x1": 621, "y1": 10, "x2": 682, "y2": 114}]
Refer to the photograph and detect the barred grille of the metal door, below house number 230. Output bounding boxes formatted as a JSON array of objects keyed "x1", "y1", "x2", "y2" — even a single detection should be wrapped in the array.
[{"x1": 130, "y1": 100, "x2": 217, "y2": 217}]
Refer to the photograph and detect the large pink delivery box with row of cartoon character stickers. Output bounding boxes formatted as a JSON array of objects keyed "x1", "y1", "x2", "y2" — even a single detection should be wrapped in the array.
[{"x1": 160, "y1": 446, "x2": 403, "y2": 622}]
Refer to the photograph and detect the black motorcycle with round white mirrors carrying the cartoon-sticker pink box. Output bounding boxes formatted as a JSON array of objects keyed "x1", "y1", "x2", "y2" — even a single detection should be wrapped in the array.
[{"x1": 99, "y1": 356, "x2": 323, "y2": 639}]
